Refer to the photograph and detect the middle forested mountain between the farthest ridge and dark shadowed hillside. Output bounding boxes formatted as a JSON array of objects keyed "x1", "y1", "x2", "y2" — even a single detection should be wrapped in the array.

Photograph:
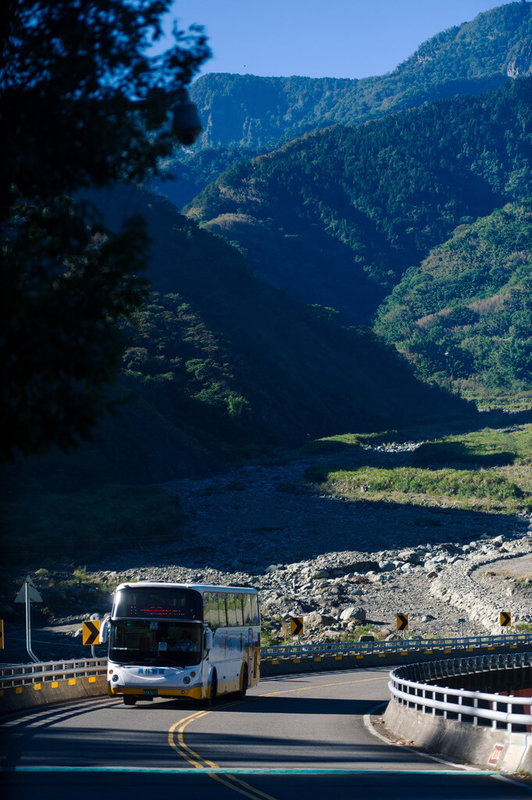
[{"x1": 187, "y1": 78, "x2": 532, "y2": 322}]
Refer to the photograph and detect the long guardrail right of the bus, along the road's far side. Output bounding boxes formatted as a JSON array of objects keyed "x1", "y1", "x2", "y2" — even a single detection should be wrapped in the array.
[{"x1": 261, "y1": 633, "x2": 532, "y2": 661}]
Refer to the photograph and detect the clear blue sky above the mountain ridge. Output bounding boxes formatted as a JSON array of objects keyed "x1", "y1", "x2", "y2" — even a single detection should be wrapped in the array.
[{"x1": 167, "y1": 0, "x2": 520, "y2": 78}]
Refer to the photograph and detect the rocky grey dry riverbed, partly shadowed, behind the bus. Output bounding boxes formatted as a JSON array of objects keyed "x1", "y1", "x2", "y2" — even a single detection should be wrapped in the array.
[{"x1": 2, "y1": 443, "x2": 532, "y2": 658}]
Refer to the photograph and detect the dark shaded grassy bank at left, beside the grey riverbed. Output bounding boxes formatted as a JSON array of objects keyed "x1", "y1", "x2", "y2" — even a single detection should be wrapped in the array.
[{"x1": 1, "y1": 484, "x2": 183, "y2": 564}]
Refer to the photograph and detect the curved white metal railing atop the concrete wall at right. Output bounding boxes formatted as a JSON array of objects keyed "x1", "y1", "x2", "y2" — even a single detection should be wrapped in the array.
[{"x1": 388, "y1": 653, "x2": 532, "y2": 733}]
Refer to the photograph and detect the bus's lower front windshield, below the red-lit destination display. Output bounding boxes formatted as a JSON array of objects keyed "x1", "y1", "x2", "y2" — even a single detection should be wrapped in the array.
[{"x1": 109, "y1": 619, "x2": 202, "y2": 667}]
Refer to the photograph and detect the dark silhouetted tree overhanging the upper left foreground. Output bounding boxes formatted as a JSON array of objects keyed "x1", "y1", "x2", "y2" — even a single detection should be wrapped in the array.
[{"x1": 0, "y1": 0, "x2": 209, "y2": 458}]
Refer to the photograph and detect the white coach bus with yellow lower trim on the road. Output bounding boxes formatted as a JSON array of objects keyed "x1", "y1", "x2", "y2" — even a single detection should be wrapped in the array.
[{"x1": 107, "y1": 581, "x2": 260, "y2": 705}]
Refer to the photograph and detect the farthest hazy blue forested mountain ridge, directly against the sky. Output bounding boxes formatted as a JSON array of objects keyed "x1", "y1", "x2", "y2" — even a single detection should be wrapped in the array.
[{"x1": 152, "y1": 2, "x2": 532, "y2": 208}]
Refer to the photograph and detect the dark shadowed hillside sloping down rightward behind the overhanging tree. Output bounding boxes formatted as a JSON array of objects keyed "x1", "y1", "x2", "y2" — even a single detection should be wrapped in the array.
[{"x1": 9, "y1": 188, "x2": 470, "y2": 491}]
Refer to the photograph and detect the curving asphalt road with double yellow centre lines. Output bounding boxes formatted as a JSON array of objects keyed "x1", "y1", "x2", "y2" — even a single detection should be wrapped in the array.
[{"x1": 1, "y1": 668, "x2": 532, "y2": 800}]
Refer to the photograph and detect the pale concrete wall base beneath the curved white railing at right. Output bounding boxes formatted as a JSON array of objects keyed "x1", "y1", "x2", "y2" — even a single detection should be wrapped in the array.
[{"x1": 384, "y1": 700, "x2": 532, "y2": 772}]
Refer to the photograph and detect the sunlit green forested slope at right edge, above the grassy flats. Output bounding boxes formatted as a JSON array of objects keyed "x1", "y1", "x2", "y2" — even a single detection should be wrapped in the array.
[{"x1": 375, "y1": 204, "x2": 532, "y2": 400}]
